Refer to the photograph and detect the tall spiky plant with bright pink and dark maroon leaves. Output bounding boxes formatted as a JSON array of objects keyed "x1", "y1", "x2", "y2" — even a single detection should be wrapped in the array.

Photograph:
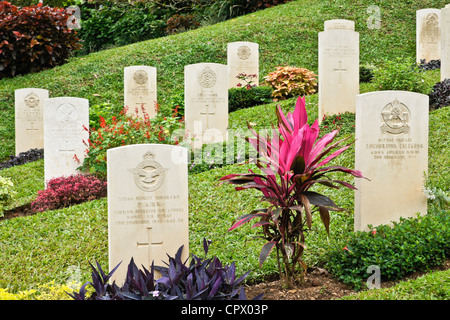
[{"x1": 220, "y1": 98, "x2": 364, "y2": 286}]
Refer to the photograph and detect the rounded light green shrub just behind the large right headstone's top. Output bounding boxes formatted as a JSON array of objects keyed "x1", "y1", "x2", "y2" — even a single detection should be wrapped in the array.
[{"x1": 372, "y1": 58, "x2": 428, "y2": 94}]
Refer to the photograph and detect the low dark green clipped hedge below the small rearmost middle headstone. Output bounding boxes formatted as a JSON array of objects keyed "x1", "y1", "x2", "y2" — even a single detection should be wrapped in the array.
[{"x1": 228, "y1": 86, "x2": 273, "y2": 112}]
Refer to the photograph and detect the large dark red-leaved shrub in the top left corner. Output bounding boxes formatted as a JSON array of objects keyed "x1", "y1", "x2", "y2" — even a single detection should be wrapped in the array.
[{"x1": 0, "y1": 1, "x2": 80, "y2": 78}]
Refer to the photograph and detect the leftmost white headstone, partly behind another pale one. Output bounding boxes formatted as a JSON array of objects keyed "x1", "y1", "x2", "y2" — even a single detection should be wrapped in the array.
[{"x1": 14, "y1": 88, "x2": 48, "y2": 155}]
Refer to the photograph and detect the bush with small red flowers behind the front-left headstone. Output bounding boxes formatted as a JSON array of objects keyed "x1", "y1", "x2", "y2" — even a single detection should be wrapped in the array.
[{"x1": 78, "y1": 106, "x2": 183, "y2": 178}]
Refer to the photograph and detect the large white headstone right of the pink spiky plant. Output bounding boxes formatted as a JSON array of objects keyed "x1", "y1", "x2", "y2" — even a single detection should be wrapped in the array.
[{"x1": 355, "y1": 91, "x2": 428, "y2": 231}]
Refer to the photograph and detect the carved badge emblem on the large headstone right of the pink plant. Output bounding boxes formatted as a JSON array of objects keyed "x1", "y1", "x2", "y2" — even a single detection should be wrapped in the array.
[{"x1": 381, "y1": 99, "x2": 411, "y2": 134}]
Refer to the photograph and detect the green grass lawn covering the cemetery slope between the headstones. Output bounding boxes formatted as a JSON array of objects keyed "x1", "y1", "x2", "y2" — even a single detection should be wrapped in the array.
[{"x1": 0, "y1": 1, "x2": 450, "y2": 298}]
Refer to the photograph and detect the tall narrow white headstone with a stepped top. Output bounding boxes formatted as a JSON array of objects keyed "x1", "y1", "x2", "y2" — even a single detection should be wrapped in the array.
[{"x1": 319, "y1": 19, "x2": 359, "y2": 122}]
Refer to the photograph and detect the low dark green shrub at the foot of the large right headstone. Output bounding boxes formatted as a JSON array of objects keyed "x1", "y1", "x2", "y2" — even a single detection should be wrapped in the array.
[{"x1": 326, "y1": 211, "x2": 450, "y2": 289}]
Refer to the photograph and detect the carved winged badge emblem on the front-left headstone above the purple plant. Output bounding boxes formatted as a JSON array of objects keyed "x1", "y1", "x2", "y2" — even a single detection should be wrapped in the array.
[{"x1": 128, "y1": 151, "x2": 168, "y2": 192}]
